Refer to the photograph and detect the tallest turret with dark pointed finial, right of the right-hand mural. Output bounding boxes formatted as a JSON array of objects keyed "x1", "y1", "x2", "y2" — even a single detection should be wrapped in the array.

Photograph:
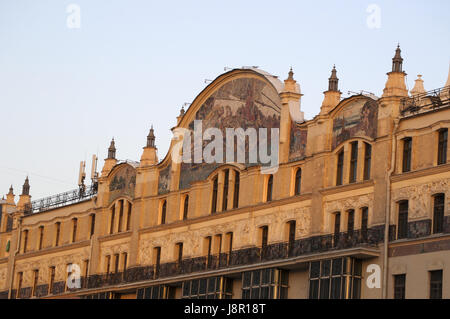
[{"x1": 382, "y1": 45, "x2": 408, "y2": 97}]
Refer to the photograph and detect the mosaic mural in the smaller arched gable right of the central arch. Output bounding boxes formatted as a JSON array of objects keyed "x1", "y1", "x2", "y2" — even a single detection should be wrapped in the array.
[{"x1": 332, "y1": 99, "x2": 378, "y2": 148}]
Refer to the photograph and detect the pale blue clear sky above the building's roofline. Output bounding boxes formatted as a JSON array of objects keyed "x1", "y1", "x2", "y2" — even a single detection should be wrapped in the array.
[{"x1": 0, "y1": 0, "x2": 450, "y2": 200}]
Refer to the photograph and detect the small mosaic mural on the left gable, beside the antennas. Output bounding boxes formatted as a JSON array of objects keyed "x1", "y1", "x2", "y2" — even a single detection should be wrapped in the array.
[{"x1": 109, "y1": 165, "x2": 136, "y2": 203}]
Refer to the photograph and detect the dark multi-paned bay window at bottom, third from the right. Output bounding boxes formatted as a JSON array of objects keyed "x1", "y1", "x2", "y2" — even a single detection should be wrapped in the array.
[{"x1": 181, "y1": 277, "x2": 233, "y2": 299}]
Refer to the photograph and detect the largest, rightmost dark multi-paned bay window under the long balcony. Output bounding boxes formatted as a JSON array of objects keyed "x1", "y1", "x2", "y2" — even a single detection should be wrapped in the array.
[{"x1": 309, "y1": 257, "x2": 362, "y2": 299}]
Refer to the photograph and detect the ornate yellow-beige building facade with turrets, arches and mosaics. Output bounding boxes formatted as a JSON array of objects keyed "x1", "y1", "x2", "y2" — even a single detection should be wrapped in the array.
[{"x1": 0, "y1": 48, "x2": 450, "y2": 299}]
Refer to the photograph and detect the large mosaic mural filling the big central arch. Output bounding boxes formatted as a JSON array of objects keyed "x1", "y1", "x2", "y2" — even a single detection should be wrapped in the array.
[{"x1": 179, "y1": 78, "x2": 281, "y2": 189}]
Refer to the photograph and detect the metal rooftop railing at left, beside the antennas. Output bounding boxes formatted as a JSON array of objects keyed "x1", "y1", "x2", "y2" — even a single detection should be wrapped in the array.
[{"x1": 25, "y1": 183, "x2": 98, "y2": 215}]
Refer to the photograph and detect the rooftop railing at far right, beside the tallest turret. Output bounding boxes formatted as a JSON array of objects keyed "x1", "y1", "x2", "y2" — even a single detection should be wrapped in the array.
[{"x1": 400, "y1": 86, "x2": 450, "y2": 116}]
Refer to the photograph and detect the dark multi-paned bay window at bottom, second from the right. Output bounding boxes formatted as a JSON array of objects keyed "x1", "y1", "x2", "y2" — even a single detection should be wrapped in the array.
[{"x1": 242, "y1": 268, "x2": 289, "y2": 299}]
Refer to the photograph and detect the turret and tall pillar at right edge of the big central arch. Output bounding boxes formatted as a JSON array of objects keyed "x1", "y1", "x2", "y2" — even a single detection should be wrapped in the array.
[{"x1": 279, "y1": 68, "x2": 305, "y2": 163}]
